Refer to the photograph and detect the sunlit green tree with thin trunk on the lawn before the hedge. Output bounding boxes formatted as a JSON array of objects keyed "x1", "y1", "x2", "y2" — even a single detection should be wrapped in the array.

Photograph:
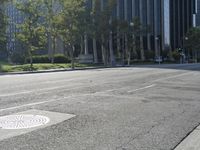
[{"x1": 16, "y1": 0, "x2": 46, "y2": 69}]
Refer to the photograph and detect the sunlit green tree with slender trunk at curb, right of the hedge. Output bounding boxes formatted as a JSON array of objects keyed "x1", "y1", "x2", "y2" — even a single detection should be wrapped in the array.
[{"x1": 57, "y1": 0, "x2": 86, "y2": 69}]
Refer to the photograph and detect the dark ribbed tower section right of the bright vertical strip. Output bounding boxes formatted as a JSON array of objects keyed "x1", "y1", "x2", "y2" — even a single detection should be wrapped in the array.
[{"x1": 170, "y1": 0, "x2": 197, "y2": 48}]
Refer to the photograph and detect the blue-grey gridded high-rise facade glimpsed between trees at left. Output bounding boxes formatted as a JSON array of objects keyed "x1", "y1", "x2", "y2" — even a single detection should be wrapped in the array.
[{"x1": 5, "y1": 0, "x2": 64, "y2": 58}]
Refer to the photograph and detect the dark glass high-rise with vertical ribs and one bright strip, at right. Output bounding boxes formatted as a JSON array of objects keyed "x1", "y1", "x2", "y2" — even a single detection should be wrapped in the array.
[{"x1": 87, "y1": 0, "x2": 196, "y2": 56}]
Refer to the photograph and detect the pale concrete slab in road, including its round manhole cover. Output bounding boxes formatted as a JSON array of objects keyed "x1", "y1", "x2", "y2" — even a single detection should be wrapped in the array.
[{"x1": 0, "y1": 109, "x2": 75, "y2": 141}]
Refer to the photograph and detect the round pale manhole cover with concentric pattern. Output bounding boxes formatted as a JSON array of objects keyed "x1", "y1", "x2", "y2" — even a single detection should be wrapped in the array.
[{"x1": 0, "y1": 115, "x2": 50, "y2": 130}]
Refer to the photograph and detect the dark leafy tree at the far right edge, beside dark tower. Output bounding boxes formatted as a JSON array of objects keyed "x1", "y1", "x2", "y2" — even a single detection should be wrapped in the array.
[{"x1": 183, "y1": 27, "x2": 200, "y2": 60}]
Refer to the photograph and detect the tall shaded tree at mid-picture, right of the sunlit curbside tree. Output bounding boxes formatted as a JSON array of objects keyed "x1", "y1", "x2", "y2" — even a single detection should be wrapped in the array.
[{"x1": 92, "y1": 0, "x2": 116, "y2": 66}]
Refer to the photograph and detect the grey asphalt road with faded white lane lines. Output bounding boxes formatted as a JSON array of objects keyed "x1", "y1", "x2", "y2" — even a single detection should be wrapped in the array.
[{"x1": 0, "y1": 64, "x2": 200, "y2": 150}]
